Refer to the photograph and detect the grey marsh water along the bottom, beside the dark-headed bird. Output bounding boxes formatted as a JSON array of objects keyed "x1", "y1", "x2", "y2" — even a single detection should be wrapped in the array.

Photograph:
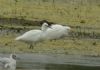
[{"x1": 0, "y1": 54, "x2": 100, "y2": 70}]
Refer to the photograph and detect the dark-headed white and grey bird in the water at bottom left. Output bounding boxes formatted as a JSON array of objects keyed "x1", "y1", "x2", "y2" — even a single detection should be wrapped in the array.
[{"x1": 0, "y1": 54, "x2": 16, "y2": 70}]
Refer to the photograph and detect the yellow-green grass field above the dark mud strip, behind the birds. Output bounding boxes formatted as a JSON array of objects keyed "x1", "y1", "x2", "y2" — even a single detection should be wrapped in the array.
[{"x1": 0, "y1": 0, "x2": 100, "y2": 27}]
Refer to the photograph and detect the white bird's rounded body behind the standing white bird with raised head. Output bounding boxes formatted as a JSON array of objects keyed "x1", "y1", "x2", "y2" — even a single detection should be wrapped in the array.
[{"x1": 44, "y1": 24, "x2": 71, "y2": 40}]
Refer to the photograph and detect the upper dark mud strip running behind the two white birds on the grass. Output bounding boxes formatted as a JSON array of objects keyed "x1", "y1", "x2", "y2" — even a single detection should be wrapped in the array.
[{"x1": 0, "y1": 17, "x2": 100, "y2": 29}]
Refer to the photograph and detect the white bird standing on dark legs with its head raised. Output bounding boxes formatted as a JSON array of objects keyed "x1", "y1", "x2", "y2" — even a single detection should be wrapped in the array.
[{"x1": 15, "y1": 23, "x2": 48, "y2": 48}]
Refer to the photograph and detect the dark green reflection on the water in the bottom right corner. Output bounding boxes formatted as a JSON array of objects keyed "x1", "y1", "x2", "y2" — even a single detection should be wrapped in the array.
[{"x1": 46, "y1": 64, "x2": 100, "y2": 70}]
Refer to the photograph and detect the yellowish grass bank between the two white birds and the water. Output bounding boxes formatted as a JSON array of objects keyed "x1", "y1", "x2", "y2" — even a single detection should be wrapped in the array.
[{"x1": 0, "y1": 35, "x2": 100, "y2": 56}]
